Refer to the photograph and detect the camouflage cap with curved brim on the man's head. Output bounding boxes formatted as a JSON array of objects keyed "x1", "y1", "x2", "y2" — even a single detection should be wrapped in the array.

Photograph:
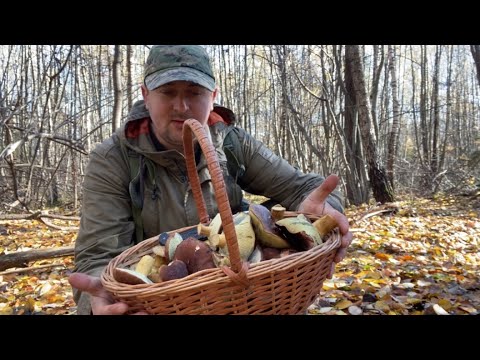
[{"x1": 144, "y1": 45, "x2": 215, "y2": 91}]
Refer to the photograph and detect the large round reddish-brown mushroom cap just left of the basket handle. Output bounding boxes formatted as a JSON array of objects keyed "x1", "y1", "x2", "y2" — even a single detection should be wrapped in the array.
[{"x1": 174, "y1": 237, "x2": 215, "y2": 274}]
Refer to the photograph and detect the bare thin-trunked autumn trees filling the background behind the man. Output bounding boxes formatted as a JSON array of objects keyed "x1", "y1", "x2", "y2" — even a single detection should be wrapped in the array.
[{"x1": 0, "y1": 45, "x2": 480, "y2": 212}]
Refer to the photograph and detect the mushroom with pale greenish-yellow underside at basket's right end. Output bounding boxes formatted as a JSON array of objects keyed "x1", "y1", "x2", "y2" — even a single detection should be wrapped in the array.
[{"x1": 276, "y1": 214, "x2": 322, "y2": 251}]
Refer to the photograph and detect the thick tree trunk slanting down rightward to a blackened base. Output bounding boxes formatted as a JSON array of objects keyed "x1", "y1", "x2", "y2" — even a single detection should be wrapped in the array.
[{"x1": 345, "y1": 45, "x2": 394, "y2": 204}]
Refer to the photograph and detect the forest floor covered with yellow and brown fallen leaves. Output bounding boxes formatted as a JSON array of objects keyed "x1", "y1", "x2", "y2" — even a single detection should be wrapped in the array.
[{"x1": 0, "y1": 192, "x2": 480, "y2": 315}]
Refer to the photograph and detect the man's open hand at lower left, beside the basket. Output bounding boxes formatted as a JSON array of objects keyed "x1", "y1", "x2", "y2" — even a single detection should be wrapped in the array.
[{"x1": 68, "y1": 273, "x2": 146, "y2": 315}]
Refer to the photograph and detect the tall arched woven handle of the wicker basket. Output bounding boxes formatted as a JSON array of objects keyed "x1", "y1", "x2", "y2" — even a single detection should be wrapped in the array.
[{"x1": 183, "y1": 119, "x2": 245, "y2": 274}]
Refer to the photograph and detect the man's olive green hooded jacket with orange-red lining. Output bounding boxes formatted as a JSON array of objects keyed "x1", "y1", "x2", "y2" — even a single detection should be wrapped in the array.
[{"x1": 74, "y1": 101, "x2": 343, "y2": 314}]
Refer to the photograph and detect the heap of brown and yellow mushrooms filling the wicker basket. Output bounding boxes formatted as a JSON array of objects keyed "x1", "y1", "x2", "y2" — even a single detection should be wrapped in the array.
[{"x1": 114, "y1": 204, "x2": 338, "y2": 285}]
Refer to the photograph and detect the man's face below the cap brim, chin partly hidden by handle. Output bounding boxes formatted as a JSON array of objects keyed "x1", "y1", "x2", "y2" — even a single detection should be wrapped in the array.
[{"x1": 142, "y1": 81, "x2": 217, "y2": 152}]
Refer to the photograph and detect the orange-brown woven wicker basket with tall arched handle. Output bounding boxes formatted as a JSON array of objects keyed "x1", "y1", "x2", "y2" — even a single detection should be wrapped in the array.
[{"x1": 101, "y1": 119, "x2": 340, "y2": 315}]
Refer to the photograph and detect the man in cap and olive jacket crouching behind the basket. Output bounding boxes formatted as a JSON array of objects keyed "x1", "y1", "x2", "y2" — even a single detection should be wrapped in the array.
[{"x1": 69, "y1": 45, "x2": 352, "y2": 314}]
